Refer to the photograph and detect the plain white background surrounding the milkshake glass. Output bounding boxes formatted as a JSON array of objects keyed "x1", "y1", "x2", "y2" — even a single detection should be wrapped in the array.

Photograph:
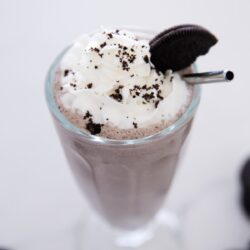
[{"x1": 0, "y1": 0, "x2": 250, "y2": 250}]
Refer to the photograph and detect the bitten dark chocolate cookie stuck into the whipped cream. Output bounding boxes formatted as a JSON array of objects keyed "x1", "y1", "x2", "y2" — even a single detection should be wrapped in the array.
[{"x1": 149, "y1": 24, "x2": 218, "y2": 73}]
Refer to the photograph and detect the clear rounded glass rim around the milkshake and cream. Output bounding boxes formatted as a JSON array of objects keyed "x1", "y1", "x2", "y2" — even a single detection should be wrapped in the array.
[{"x1": 45, "y1": 29, "x2": 201, "y2": 145}]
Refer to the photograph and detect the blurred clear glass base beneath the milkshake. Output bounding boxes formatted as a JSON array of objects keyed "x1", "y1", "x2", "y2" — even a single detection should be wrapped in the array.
[{"x1": 80, "y1": 210, "x2": 182, "y2": 250}]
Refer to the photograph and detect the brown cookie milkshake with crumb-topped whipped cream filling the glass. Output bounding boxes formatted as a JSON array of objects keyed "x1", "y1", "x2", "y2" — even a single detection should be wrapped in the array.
[{"x1": 47, "y1": 26, "x2": 216, "y2": 229}]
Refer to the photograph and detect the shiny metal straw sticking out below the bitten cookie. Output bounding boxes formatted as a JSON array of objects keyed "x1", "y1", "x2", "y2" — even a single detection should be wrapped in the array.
[{"x1": 182, "y1": 70, "x2": 234, "y2": 85}]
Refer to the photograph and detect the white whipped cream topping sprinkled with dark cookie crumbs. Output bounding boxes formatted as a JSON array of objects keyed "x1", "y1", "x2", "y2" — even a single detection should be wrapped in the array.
[{"x1": 60, "y1": 30, "x2": 189, "y2": 129}]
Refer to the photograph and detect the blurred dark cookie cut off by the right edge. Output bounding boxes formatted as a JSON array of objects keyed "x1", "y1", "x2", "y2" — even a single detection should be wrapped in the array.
[{"x1": 241, "y1": 158, "x2": 250, "y2": 217}]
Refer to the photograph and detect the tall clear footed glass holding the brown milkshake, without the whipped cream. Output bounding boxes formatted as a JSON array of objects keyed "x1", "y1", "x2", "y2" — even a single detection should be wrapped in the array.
[{"x1": 46, "y1": 28, "x2": 200, "y2": 250}]
